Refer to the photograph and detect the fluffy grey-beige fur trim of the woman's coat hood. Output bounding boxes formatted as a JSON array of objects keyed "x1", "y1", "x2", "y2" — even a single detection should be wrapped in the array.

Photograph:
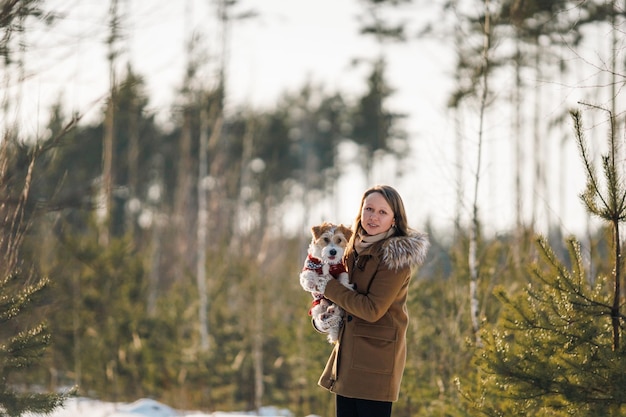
[{"x1": 381, "y1": 231, "x2": 430, "y2": 271}]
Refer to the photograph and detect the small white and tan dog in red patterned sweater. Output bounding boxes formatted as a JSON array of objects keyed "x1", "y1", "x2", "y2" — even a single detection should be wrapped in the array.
[{"x1": 300, "y1": 222, "x2": 354, "y2": 343}]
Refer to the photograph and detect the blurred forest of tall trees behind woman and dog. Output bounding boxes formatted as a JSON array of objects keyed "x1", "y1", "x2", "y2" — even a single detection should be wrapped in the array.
[{"x1": 0, "y1": 0, "x2": 626, "y2": 416}]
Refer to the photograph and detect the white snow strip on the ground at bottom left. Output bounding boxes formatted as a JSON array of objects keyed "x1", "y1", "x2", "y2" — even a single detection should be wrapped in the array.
[{"x1": 24, "y1": 398, "x2": 314, "y2": 417}]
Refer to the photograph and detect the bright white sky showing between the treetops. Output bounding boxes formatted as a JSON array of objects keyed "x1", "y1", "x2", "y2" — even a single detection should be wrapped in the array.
[{"x1": 7, "y1": 0, "x2": 600, "y2": 237}]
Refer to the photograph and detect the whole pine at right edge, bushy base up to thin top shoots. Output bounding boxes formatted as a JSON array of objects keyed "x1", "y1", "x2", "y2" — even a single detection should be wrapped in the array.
[{"x1": 460, "y1": 106, "x2": 626, "y2": 416}]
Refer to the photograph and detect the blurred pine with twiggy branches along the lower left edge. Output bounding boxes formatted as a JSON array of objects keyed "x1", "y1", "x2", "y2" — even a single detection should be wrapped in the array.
[{"x1": 0, "y1": 138, "x2": 70, "y2": 417}]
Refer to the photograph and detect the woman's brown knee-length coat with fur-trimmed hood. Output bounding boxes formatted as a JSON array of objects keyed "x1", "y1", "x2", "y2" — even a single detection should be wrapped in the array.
[{"x1": 318, "y1": 233, "x2": 429, "y2": 401}]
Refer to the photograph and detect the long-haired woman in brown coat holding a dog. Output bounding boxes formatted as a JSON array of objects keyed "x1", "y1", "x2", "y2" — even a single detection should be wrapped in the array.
[{"x1": 310, "y1": 185, "x2": 429, "y2": 417}]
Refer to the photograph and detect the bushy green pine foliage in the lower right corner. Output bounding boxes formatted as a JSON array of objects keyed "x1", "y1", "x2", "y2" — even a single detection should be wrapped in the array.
[{"x1": 478, "y1": 238, "x2": 626, "y2": 416}]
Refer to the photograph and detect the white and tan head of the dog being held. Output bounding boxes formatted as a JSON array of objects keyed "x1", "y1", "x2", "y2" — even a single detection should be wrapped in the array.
[{"x1": 309, "y1": 222, "x2": 352, "y2": 264}]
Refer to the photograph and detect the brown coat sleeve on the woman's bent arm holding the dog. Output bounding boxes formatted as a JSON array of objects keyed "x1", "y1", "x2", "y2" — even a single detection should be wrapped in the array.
[{"x1": 324, "y1": 266, "x2": 411, "y2": 323}]
